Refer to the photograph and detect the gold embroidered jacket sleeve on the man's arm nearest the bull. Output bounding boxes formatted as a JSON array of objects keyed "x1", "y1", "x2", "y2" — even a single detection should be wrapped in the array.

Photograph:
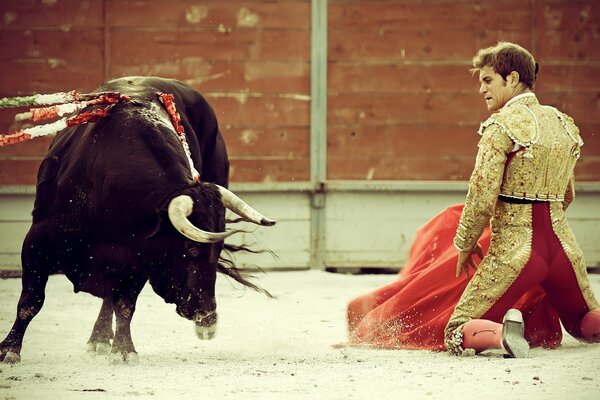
[{"x1": 454, "y1": 124, "x2": 515, "y2": 251}]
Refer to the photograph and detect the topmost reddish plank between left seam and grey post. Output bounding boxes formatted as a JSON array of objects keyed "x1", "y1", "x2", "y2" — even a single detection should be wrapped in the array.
[{"x1": 107, "y1": 0, "x2": 310, "y2": 31}]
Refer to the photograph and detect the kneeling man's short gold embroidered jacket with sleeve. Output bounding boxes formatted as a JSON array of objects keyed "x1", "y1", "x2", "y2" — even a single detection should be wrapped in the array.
[{"x1": 454, "y1": 93, "x2": 583, "y2": 251}]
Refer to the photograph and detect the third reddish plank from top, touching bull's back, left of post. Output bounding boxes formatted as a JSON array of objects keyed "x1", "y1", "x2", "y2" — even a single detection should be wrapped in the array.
[{"x1": 111, "y1": 57, "x2": 310, "y2": 95}]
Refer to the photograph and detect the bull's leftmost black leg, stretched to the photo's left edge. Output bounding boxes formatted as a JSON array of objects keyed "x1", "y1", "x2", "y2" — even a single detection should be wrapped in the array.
[{"x1": 0, "y1": 226, "x2": 48, "y2": 364}]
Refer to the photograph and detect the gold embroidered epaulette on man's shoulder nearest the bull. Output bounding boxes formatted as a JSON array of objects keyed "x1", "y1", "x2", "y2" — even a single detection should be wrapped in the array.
[{"x1": 479, "y1": 105, "x2": 540, "y2": 147}]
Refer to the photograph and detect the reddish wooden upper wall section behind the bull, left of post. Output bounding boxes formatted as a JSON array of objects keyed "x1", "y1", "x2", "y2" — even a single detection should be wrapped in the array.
[{"x1": 0, "y1": 0, "x2": 310, "y2": 185}]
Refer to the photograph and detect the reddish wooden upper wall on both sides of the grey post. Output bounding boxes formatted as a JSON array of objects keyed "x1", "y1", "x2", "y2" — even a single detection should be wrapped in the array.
[{"x1": 0, "y1": 0, "x2": 600, "y2": 185}]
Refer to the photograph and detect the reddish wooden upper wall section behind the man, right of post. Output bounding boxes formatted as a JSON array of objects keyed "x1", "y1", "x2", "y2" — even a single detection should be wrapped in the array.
[{"x1": 328, "y1": 0, "x2": 600, "y2": 181}]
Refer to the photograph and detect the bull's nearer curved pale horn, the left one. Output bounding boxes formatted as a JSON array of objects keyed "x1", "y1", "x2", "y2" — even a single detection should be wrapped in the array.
[{"x1": 168, "y1": 195, "x2": 235, "y2": 243}]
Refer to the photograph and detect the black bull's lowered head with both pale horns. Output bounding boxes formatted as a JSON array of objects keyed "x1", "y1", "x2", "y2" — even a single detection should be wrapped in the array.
[{"x1": 168, "y1": 185, "x2": 276, "y2": 339}]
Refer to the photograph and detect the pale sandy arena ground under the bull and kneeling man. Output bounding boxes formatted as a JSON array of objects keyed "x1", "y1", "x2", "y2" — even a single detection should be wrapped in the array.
[{"x1": 0, "y1": 271, "x2": 600, "y2": 400}]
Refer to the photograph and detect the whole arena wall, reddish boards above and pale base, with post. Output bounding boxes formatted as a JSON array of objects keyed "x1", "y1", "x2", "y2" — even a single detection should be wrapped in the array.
[{"x1": 0, "y1": 0, "x2": 600, "y2": 269}]
